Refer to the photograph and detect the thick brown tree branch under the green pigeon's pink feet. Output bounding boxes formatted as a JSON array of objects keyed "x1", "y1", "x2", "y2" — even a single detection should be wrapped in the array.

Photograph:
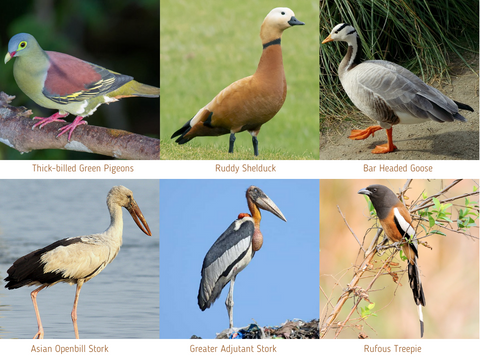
[{"x1": 0, "y1": 92, "x2": 160, "y2": 160}]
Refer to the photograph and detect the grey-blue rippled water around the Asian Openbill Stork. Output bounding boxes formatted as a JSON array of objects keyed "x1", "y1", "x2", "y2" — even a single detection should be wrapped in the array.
[{"x1": 0, "y1": 180, "x2": 159, "y2": 339}]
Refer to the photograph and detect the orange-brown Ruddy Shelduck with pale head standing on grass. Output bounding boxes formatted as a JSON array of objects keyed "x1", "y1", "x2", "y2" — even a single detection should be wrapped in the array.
[{"x1": 171, "y1": 7, "x2": 305, "y2": 156}]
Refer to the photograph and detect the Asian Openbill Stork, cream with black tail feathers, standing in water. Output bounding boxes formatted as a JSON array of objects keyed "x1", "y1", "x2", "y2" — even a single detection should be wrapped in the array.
[{"x1": 5, "y1": 185, "x2": 152, "y2": 339}]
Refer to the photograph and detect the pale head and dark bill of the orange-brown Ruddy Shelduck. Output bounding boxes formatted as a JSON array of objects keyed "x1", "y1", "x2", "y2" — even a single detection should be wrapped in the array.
[{"x1": 260, "y1": 8, "x2": 305, "y2": 43}]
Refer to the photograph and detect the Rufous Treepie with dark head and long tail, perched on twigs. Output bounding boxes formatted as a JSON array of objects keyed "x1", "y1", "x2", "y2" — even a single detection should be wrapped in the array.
[{"x1": 358, "y1": 185, "x2": 427, "y2": 337}]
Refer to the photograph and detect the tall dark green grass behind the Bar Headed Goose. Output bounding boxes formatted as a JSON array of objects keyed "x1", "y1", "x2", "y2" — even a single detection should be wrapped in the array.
[{"x1": 320, "y1": 0, "x2": 479, "y2": 132}]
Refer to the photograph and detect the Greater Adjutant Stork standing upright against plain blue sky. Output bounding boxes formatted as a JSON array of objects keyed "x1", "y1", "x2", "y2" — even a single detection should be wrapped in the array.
[{"x1": 198, "y1": 186, "x2": 287, "y2": 328}]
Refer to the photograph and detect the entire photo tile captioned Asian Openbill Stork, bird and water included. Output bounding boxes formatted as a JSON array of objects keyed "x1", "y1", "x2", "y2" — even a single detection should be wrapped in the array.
[{"x1": 0, "y1": 180, "x2": 159, "y2": 339}]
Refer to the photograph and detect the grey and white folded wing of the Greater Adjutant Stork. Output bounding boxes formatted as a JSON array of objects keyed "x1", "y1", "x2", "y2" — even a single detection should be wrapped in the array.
[{"x1": 198, "y1": 217, "x2": 255, "y2": 311}]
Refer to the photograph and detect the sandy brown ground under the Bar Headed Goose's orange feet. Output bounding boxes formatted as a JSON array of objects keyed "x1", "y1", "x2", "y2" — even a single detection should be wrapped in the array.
[{"x1": 320, "y1": 57, "x2": 479, "y2": 160}]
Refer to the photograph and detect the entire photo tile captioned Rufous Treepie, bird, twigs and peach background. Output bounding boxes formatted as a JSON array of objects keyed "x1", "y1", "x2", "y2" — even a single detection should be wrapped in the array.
[{"x1": 320, "y1": 179, "x2": 479, "y2": 339}]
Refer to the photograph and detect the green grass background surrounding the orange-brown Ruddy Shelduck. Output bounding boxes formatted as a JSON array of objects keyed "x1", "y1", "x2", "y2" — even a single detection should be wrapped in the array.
[{"x1": 160, "y1": 0, "x2": 319, "y2": 159}]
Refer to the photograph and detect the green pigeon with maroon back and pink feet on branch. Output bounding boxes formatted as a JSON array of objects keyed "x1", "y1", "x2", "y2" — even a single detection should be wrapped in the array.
[{"x1": 5, "y1": 33, "x2": 160, "y2": 141}]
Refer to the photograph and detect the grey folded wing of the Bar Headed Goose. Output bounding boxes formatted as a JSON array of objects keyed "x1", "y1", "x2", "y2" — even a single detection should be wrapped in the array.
[{"x1": 357, "y1": 60, "x2": 466, "y2": 122}]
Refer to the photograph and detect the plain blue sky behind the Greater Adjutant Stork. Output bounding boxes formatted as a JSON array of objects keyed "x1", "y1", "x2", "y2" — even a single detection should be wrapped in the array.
[{"x1": 160, "y1": 180, "x2": 319, "y2": 339}]
